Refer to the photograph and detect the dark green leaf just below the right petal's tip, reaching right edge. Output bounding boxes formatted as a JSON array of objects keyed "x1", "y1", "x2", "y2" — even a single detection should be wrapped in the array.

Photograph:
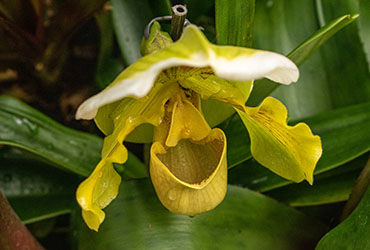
[{"x1": 266, "y1": 154, "x2": 368, "y2": 206}]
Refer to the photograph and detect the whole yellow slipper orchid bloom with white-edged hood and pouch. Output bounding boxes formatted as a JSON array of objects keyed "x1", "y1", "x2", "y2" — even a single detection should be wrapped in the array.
[{"x1": 76, "y1": 23, "x2": 322, "y2": 231}]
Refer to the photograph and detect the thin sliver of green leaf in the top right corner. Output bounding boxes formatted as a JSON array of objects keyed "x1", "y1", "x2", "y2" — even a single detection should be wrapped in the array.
[{"x1": 357, "y1": 0, "x2": 370, "y2": 70}]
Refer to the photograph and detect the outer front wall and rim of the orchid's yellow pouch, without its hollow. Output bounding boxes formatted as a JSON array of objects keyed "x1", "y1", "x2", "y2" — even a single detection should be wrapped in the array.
[{"x1": 150, "y1": 129, "x2": 227, "y2": 216}]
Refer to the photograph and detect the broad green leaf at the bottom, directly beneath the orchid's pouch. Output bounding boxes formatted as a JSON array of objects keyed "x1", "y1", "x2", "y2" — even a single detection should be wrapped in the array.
[{"x1": 75, "y1": 180, "x2": 326, "y2": 250}]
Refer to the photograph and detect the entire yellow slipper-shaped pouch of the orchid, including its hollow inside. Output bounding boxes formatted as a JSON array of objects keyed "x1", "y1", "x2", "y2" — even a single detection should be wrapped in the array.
[{"x1": 150, "y1": 129, "x2": 227, "y2": 216}]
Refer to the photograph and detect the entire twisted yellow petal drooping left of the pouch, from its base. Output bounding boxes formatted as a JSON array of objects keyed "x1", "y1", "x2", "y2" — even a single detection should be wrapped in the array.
[{"x1": 77, "y1": 83, "x2": 179, "y2": 231}]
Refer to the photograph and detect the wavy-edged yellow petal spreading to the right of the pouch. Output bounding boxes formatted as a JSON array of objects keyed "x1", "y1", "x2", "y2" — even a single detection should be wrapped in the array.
[{"x1": 236, "y1": 97, "x2": 322, "y2": 184}]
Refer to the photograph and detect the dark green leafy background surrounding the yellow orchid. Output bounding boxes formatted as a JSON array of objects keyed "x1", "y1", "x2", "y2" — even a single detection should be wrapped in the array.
[{"x1": 0, "y1": 0, "x2": 370, "y2": 250}]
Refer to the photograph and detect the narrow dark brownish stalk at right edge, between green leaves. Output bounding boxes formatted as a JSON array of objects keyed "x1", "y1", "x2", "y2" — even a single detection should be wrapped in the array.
[{"x1": 341, "y1": 154, "x2": 370, "y2": 221}]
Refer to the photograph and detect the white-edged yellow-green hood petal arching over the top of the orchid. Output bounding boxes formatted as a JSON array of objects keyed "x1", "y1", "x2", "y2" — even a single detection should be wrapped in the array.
[{"x1": 76, "y1": 25, "x2": 299, "y2": 119}]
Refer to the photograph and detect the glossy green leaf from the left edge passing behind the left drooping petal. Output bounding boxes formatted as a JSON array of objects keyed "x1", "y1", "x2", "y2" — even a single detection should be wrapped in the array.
[{"x1": 0, "y1": 96, "x2": 146, "y2": 178}]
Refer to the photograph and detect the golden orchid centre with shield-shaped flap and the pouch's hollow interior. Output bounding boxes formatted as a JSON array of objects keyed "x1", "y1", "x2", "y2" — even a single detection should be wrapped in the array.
[{"x1": 154, "y1": 88, "x2": 225, "y2": 184}]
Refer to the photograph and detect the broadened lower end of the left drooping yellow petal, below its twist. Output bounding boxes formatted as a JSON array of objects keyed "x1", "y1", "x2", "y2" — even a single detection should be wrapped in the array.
[{"x1": 76, "y1": 159, "x2": 121, "y2": 231}]
